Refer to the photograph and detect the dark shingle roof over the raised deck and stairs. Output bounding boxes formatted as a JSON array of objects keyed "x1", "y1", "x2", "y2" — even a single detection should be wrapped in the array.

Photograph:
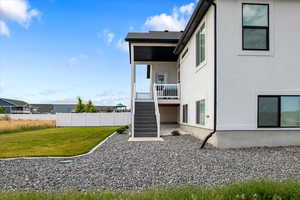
[{"x1": 125, "y1": 31, "x2": 182, "y2": 43}]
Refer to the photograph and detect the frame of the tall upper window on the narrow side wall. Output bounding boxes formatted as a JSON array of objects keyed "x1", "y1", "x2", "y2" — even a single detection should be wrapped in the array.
[{"x1": 196, "y1": 20, "x2": 207, "y2": 68}]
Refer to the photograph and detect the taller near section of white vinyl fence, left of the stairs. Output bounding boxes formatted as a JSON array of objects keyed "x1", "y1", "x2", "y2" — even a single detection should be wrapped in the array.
[{"x1": 56, "y1": 112, "x2": 131, "y2": 127}]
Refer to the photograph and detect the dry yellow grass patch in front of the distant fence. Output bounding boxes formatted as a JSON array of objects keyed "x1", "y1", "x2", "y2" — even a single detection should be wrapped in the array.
[{"x1": 0, "y1": 118, "x2": 56, "y2": 134}]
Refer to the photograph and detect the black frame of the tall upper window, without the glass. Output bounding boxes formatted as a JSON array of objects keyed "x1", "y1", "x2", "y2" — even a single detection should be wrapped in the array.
[{"x1": 242, "y1": 3, "x2": 270, "y2": 51}]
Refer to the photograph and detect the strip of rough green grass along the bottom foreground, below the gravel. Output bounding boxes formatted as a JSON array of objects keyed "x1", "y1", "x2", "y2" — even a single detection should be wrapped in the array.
[{"x1": 0, "y1": 181, "x2": 300, "y2": 200}]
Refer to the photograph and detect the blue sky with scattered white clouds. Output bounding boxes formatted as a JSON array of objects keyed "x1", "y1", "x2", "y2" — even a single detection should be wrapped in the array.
[{"x1": 0, "y1": 0, "x2": 195, "y2": 105}]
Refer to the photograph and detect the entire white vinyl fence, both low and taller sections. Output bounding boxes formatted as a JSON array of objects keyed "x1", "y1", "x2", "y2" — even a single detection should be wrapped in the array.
[{"x1": 0, "y1": 112, "x2": 131, "y2": 127}]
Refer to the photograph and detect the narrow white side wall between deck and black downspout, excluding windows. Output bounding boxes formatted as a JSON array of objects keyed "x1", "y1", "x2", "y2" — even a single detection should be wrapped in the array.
[{"x1": 180, "y1": 7, "x2": 214, "y2": 137}]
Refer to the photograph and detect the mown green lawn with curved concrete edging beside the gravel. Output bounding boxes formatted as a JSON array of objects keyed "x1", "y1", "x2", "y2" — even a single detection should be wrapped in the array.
[{"x1": 0, "y1": 127, "x2": 118, "y2": 158}]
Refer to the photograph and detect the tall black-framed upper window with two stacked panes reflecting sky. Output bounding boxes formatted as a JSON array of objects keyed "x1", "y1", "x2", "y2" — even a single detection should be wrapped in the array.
[{"x1": 242, "y1": 3, "x2": 270, "y2": 51}]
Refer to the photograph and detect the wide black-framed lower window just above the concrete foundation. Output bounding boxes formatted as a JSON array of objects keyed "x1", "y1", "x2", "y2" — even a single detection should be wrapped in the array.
[{"x1": 257, "y1": 95, "x2": 300, "y2": 128}]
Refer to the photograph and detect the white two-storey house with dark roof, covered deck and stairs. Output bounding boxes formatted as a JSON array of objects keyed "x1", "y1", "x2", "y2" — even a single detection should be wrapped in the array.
[{"x1": 126, "y1": 0, "x2": 300, "y2": 148}]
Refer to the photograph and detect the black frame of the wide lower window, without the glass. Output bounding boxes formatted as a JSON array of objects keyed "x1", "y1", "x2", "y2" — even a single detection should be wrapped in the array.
[{"x1": 257, "y1": 95, "x2": 300, "y2": 129}]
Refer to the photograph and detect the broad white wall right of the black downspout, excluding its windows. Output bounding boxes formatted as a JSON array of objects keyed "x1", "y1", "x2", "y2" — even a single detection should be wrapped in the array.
[{"x1": 217, "y1": 0, "x2": 300, "y2": 130}]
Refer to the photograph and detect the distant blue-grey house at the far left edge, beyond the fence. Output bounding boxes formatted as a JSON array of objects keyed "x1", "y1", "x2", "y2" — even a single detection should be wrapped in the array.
[{"x1": 0, "y1": 98, "x2": 31, "y2": 114}]
